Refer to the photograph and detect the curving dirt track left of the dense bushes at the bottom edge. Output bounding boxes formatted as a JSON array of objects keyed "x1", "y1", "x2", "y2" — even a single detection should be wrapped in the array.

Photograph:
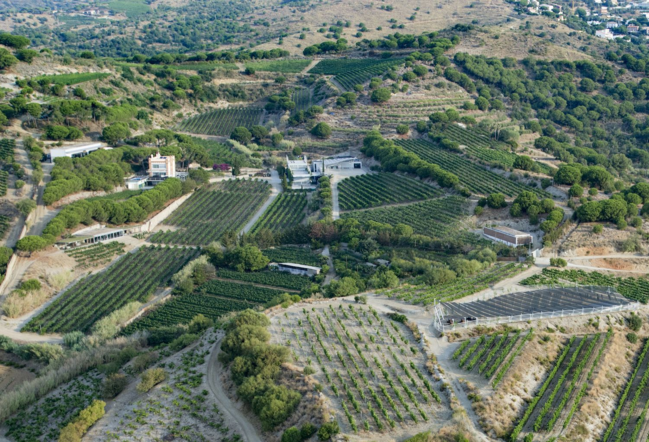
[{"x1": 207, "y1": 337, "x2": 263, "y2": 442}]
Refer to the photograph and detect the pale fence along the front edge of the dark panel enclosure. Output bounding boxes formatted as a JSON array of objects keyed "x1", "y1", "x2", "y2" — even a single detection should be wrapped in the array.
[{"x1": 434, "y1": 302, "x2": 640, "y2": 332}]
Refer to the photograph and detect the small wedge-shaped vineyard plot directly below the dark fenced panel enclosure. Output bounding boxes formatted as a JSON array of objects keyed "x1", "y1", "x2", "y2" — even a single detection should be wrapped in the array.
[{"x1": 451, "y1": 329, "x2": 533, "y2": 388}]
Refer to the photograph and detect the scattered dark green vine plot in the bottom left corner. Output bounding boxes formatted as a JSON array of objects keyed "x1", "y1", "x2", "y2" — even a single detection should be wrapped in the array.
[{"x1": 4, "y1": 370, "x2": 104, "y2": 442}]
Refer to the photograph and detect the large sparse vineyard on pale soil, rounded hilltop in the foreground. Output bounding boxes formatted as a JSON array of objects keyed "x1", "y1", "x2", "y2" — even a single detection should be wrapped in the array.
[{"x1": 270, "y1": 302, "x2": 445, "y2": 440}]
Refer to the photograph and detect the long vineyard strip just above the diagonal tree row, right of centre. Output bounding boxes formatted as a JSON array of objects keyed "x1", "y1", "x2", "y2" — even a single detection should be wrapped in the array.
[{"x1": 397, "y1": 140, "x2": 551, "y2": 198}]
